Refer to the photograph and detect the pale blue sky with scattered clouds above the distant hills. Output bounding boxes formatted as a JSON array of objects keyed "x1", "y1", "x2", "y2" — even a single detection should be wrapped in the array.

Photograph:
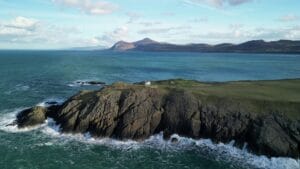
[{"x1": 0, "y1": 0, "x2": 300, "y2": 49}]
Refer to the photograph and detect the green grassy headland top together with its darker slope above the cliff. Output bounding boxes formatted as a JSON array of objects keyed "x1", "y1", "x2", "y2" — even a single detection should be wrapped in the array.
[{"x1": 146, "y1": 79, "x2": 300, "y2": 120}]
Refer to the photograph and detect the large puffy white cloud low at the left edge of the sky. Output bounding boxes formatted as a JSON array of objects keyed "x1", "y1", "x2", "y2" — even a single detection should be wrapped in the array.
[{"x1": 0, "y1": 16, "x2": 83, "y2": 48}]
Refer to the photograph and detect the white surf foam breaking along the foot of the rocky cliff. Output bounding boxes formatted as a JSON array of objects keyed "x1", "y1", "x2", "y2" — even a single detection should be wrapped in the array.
[{"x1": 0, "y1": 109, "x2": 300, "y2": 169}]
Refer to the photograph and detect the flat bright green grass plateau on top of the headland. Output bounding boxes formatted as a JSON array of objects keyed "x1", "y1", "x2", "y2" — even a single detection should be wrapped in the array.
[{"x1": 152, "y1": 79, "x2": 300, "y2": 102}]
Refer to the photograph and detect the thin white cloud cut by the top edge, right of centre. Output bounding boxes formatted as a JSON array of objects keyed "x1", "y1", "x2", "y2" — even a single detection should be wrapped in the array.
[{"x1": 184, "y1": 0, "x2": 252, "y2": 8}]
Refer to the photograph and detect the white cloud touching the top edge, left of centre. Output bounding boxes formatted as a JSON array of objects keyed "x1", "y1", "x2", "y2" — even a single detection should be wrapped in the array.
[{"x1": 52, "y1": 0, "x2": 117, "y2": 15}]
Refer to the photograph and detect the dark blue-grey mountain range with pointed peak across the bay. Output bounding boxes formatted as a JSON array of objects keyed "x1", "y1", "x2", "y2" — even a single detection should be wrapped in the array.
[{"x1": 110, "y1": 38, "x2": 300, "y2": 53}]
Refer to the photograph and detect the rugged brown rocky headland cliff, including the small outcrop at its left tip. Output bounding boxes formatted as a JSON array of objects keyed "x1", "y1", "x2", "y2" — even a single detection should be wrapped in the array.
[{"x1": 15, "y1": 80, "x2": 300, "y2": 158}]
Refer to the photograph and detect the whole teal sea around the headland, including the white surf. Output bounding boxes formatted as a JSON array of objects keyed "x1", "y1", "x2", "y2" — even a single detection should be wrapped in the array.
[{"x1": 0, "y1": 50, "x2": 300, "y2": 169}]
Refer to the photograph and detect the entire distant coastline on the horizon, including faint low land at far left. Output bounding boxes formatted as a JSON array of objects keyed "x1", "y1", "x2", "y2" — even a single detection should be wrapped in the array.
[{"x1": 0, "y1": 38, "x2": 300, "y2": 54}]
